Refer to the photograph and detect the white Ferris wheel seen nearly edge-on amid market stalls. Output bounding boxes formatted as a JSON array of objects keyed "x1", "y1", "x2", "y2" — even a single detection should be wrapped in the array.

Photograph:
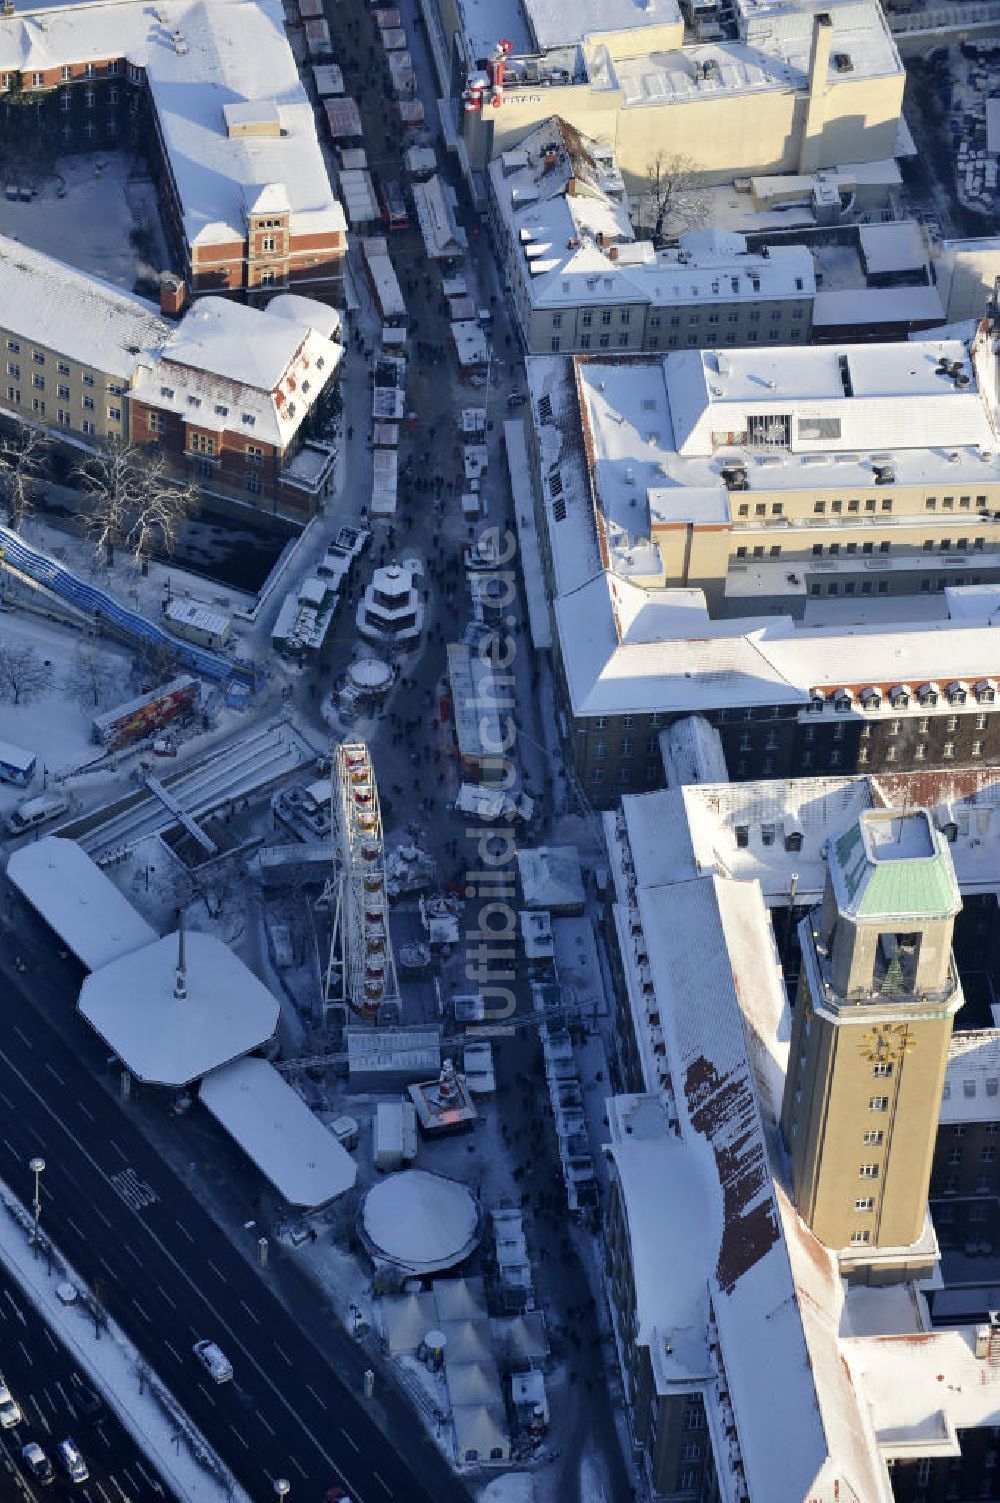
[{"x1": 323, "y1": 741, "x2": 398, "y2": 1018}]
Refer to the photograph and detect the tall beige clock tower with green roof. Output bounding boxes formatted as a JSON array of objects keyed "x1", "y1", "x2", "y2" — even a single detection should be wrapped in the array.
[{"x1": 782, "y1": 809, "x2": 962, "y2": 1281}]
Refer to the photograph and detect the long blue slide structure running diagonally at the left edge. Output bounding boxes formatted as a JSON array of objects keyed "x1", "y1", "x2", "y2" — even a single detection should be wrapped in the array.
[{"x1": 0, "y1": 526, "x2": 262, "y2": 691}]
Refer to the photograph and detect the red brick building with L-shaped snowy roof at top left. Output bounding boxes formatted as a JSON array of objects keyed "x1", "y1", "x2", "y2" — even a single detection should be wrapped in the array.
[{"x1": 0, "y1": 0, "x2": 347, "y2": 301}]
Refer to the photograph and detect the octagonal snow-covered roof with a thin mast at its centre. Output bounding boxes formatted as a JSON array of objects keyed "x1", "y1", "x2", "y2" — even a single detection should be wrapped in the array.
[{"x1": 77, "y1": 933, "x2": 278, "y2": 1085}]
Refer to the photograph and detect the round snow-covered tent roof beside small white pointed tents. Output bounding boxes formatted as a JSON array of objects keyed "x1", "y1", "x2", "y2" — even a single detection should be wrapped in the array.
[{"x1": 361, "y1": 1169, "x2": 480, "y2": 1273}]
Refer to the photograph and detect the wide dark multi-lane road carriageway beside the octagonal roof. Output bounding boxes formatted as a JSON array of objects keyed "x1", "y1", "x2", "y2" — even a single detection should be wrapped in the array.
[{"x1": 0, "y1": 919, "x2": 468, "y2": 1503}]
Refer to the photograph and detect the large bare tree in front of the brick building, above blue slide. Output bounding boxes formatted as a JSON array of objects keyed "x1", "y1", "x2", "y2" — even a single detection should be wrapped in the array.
[{"x1": 77, "y1": 437, "x2": 200, "y2": 565}]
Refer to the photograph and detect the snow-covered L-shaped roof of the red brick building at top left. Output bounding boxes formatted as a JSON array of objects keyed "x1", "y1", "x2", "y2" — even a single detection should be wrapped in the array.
[{"x1": 0, "y1": 0, "x2": 346, "y2": 243}]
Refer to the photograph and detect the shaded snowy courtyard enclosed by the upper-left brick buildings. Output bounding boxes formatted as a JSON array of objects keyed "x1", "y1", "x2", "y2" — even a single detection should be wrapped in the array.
[{"x1": 0, "y1": 144, "x2": 171, "y2": 296}]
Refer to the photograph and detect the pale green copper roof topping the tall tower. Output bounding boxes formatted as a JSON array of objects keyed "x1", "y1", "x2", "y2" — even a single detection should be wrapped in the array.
[{"x1": 830, "y1": 809, "x2": 962, "y2": 920}]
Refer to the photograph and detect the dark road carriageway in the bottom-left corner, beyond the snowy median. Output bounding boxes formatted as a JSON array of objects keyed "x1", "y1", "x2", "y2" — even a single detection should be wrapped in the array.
[{"x1": 0, "y1": 1270, "x2": 182, "y2": 1503}]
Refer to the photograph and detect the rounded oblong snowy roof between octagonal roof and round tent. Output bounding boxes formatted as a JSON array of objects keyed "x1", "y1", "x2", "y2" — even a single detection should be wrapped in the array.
[{"x1": 198, "y1": 1055, "x2": 356, "y2": 1208}]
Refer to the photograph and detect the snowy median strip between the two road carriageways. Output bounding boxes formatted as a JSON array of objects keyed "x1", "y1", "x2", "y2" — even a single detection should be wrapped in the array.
[{"x1": 0, "y1": 1183, "x2": 250, "y2": 1503}]
